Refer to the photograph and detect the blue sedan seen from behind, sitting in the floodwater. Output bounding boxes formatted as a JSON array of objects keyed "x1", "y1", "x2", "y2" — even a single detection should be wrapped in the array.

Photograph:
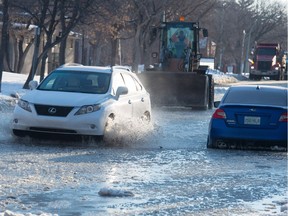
[{"x1": 207, "y1": 85, "x2": 288, "y2": 151}]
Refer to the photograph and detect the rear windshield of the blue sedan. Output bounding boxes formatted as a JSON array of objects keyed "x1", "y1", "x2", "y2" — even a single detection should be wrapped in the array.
[{"x1": 223, "y1": 88, "x2": 287, "y2": 107}]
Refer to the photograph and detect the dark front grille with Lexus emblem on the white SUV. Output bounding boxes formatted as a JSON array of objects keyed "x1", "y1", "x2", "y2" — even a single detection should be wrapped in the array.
[{"x1": 34, "y1": 104, "x2": 73, "y2": 117}]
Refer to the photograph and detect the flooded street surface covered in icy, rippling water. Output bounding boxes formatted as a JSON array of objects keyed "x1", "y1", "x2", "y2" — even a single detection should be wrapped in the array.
[{"x1": 0, "y1": 85, "x2": 287, "y2": 216}]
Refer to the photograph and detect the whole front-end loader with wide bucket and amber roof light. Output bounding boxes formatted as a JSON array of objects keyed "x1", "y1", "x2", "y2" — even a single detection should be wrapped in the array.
[{"x1": 138, "y1": 18, "x2": 214, "y2": 109}]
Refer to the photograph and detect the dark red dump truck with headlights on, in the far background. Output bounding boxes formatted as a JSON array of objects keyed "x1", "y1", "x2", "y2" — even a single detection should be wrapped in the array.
[{"x1": 249, "y1": 43, "x2": 284, "y2": 80}]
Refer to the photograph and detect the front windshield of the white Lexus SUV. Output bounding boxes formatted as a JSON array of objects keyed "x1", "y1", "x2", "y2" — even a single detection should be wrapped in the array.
[{"x1": 37, "y1": 70, "x2": 111, "y2": 94}]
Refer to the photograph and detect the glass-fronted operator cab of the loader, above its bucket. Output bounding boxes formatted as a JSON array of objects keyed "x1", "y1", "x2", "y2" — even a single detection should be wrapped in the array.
[{"x1": 160, "y1": 22, "x2": 208, "y2": 72}]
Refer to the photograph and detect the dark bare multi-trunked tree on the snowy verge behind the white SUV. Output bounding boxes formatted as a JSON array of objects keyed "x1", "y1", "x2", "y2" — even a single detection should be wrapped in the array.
[{"x1": 10, "y1": 0, "x2": 93, "y2": 88}]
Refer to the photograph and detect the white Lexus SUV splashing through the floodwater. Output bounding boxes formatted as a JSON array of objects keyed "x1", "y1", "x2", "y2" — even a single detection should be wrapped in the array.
[{"x1": 12, "y1": 65, "x2": 151, "y2": 137}]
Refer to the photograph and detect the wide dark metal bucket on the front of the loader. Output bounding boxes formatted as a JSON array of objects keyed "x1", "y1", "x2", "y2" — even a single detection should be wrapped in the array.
[{"x1": 137, "y1": 71, "x2": 214, "y2": 109}]
